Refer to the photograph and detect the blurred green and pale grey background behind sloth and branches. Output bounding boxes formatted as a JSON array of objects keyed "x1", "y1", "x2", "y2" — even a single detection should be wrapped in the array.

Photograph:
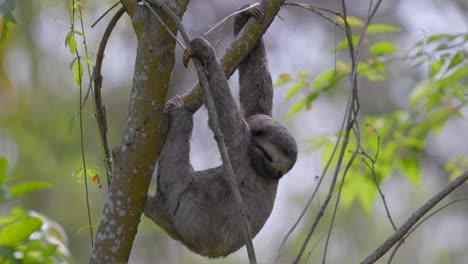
[{"x1": 0, "y1": 0, "x2": 468, "y2": 264}]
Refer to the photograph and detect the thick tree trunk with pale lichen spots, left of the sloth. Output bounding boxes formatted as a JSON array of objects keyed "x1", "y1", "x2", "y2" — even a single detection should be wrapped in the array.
[{"x1": 90, "y1": 0, "x2": 188, "y2": 263}]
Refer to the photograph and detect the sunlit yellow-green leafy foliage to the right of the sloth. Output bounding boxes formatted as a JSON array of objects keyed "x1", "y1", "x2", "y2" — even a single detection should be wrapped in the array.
[{"x1": 276, "y1": 17, "x2": 468, "y2": 211}]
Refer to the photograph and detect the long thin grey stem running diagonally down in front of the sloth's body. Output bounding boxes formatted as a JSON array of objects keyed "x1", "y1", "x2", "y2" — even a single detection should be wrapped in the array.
[{"x1": 142, "y1": 0, "x2": 257, "y2": 264}]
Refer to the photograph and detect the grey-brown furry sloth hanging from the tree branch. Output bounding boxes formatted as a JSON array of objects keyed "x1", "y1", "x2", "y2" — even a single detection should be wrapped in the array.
[{"x1": 144, "y1": 6, "x2": 297, "y2": 258}]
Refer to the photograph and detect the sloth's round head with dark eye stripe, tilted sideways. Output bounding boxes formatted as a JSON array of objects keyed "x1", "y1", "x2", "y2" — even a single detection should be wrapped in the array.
[{"x1": 247, "y1": 114, "x2": 297, "y2": 180}]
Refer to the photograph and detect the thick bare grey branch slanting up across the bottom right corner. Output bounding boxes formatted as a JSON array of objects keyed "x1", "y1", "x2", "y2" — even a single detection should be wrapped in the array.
[{"x1": 361, "y1": 171, "x2": 468, "y2": 264}]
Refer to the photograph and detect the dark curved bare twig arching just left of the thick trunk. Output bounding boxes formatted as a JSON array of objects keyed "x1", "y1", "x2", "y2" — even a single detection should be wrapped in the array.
[{"x1": 93, "y1": 7, "x2": 125, "y2": 187}]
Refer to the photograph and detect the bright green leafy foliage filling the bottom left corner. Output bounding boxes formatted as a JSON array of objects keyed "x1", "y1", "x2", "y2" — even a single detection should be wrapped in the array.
[{"x1": 0, "y1": 158, "x2": 69, "y2": 264}]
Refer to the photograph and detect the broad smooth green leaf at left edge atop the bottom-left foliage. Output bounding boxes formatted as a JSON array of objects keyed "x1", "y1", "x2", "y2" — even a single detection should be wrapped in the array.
[{"x1": 0, "y1": 216, "x2": 42, "y2": 246}]
